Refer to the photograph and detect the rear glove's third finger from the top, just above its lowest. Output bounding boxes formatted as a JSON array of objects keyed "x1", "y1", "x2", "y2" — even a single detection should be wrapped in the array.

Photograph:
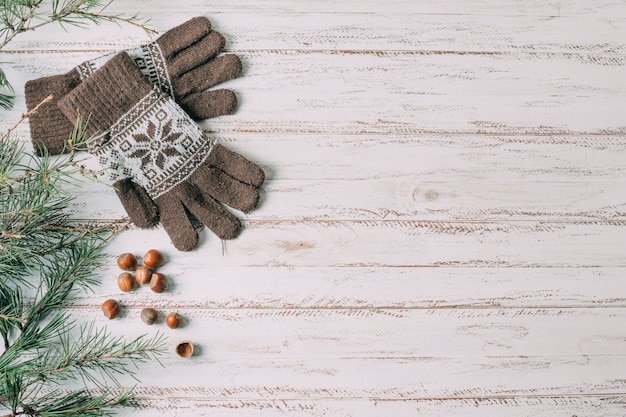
[{"x1": 172, "y1": 54, "x2": 241, "y2": 97}]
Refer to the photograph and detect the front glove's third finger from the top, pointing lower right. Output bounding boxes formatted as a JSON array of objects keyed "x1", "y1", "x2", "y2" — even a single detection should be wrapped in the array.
[{"x1": 176, "y1": 183, "x2": 241, "y2": 239}]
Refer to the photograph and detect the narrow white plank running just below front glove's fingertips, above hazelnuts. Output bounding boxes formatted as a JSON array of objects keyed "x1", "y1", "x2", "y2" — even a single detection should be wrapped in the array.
[{"x1": 89, "y1": 220, "x2": 626, "y2": 268}]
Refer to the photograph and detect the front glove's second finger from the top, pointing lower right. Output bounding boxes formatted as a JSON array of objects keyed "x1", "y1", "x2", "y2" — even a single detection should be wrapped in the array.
[{"x1": 190, "y1": 165, "x2": 259, "y2": 213}]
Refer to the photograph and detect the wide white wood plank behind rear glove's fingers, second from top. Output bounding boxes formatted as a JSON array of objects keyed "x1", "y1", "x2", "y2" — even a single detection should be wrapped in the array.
[{"x1": 0, "y1": 50, "x2": 626, "y2": 138}]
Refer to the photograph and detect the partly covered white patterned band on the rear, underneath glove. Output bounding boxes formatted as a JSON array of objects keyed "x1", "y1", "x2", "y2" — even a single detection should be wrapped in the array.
[{"x1": 76, "y1": 42, "x2": 174, "y2": 97}]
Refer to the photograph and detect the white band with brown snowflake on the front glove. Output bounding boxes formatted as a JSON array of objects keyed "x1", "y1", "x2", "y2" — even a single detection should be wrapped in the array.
[{"x1": 95, "y1": 86, "x2": 215, "y2": 199}]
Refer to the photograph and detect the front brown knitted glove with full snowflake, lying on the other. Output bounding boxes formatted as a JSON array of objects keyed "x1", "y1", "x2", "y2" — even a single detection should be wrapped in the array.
[{"x1": 58, "y1": 52, "x2": 264, "y2": 250}]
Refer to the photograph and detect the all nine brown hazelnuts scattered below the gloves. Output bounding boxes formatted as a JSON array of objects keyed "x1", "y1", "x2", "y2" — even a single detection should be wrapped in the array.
[{"x1": 102, "y1": 249, "x2": 193, "y2": 357}]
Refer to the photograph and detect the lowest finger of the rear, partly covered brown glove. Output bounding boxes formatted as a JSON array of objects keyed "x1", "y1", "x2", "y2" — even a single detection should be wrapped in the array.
[{"x1": 178, "y1": 89, "x2": 237, "y2": 120}]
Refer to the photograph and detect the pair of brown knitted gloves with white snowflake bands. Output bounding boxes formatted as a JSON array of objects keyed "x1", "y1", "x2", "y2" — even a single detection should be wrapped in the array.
[{"x1": 25, "y1": 17, "x2": 264, "y2": 250}]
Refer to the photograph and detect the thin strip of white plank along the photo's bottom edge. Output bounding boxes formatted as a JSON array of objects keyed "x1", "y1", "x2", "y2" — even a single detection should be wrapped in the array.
[{"x1": 125, "y1": 395, "x2": 626, "y2": 417}]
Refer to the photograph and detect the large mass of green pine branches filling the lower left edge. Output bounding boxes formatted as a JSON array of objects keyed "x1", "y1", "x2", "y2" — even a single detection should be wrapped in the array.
[{"x1": 0, "y1": 96, "x2": 164, "y2": 417}]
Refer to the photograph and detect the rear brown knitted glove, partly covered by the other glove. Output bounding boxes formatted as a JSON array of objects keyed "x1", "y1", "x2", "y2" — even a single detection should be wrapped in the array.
[{"x1": 25, "y1": 17, "x2": 241, "y2": 155}]
